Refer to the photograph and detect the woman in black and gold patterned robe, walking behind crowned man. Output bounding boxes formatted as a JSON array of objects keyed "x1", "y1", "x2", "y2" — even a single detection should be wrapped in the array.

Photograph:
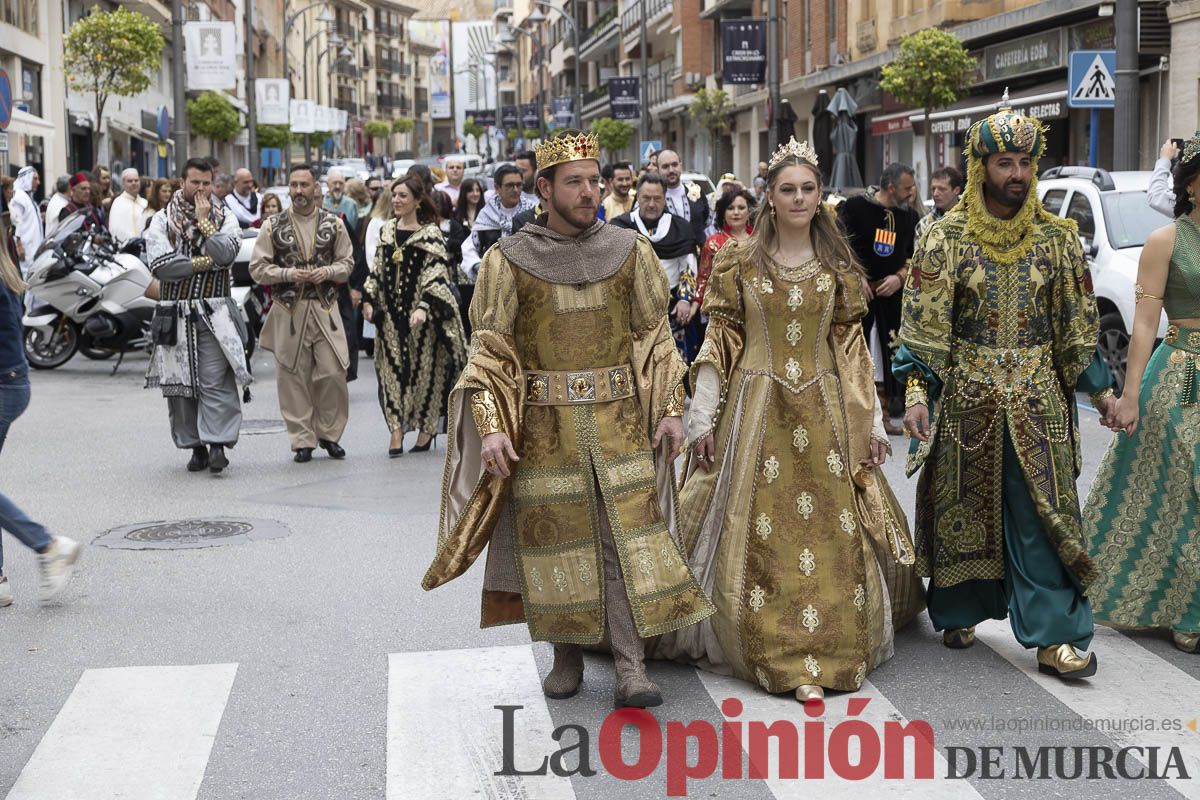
[{"x1": 362, "y1": 176, "x2": 467, "y2": 458}]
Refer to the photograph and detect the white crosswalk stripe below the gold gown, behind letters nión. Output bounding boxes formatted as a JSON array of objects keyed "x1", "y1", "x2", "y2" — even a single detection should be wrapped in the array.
[{"x1": 696, "y1": 670, "x2": 980, "y2": 800}]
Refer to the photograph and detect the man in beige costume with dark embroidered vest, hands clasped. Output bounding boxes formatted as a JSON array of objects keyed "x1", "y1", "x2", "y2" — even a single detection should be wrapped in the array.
[{"x1": 250, "y1": 164, "x2": 354, "y2": 464}]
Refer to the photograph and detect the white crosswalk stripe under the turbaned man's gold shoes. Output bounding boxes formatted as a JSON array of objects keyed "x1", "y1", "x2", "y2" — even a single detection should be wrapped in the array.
[{"x1": 976, "y1": 620, "x2": 1200, "y2": 800}]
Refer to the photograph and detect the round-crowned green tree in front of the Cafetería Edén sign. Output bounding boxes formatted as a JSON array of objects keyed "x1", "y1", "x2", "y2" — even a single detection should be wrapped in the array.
[{"x1": 880, "y1": 28, "x2": 976, "y2": 194}]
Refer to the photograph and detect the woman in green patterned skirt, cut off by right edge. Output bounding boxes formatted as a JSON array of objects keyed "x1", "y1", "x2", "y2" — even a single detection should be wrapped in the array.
[{"x1": 1084, "y1": 131, "x2": 1200, "y2": 652}]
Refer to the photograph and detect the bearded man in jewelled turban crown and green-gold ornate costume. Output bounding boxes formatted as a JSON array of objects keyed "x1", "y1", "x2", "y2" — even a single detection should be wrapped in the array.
[{"x1": 893, "y1": 92, "x2": 1114, "y2": 679}]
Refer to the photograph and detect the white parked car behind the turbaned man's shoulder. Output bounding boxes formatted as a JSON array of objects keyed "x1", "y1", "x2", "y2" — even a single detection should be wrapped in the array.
[{"x1": 1038, "y1": 167, "x2": 1169, "y2": 387}]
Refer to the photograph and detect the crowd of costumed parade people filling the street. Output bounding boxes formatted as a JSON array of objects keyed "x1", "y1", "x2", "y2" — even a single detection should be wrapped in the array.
[{"x1": 0, "y1": 112, "x2": 1200, "y2": 719}]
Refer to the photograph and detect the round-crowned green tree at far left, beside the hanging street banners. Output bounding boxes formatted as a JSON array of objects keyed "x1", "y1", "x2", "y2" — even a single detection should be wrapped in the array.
[{"x1": 65, "y1": 6, "x2": 164, "y2": 164}]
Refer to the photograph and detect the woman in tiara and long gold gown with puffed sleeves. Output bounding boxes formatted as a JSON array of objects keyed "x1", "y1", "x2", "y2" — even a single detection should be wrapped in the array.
[{"x1": 659, "y1": 139, "x2": 922, "y2": 700}]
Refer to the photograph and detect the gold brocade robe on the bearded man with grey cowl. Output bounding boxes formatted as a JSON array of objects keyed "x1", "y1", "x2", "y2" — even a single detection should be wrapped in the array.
[{"x1": 422, "y1": 225, "x2": 713, "y2": 644}]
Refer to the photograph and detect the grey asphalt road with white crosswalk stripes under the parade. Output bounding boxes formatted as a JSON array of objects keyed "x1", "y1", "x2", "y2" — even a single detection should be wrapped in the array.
[{"x1": 0, "y1": 354, "x2": 1200, "y2": 800}]
